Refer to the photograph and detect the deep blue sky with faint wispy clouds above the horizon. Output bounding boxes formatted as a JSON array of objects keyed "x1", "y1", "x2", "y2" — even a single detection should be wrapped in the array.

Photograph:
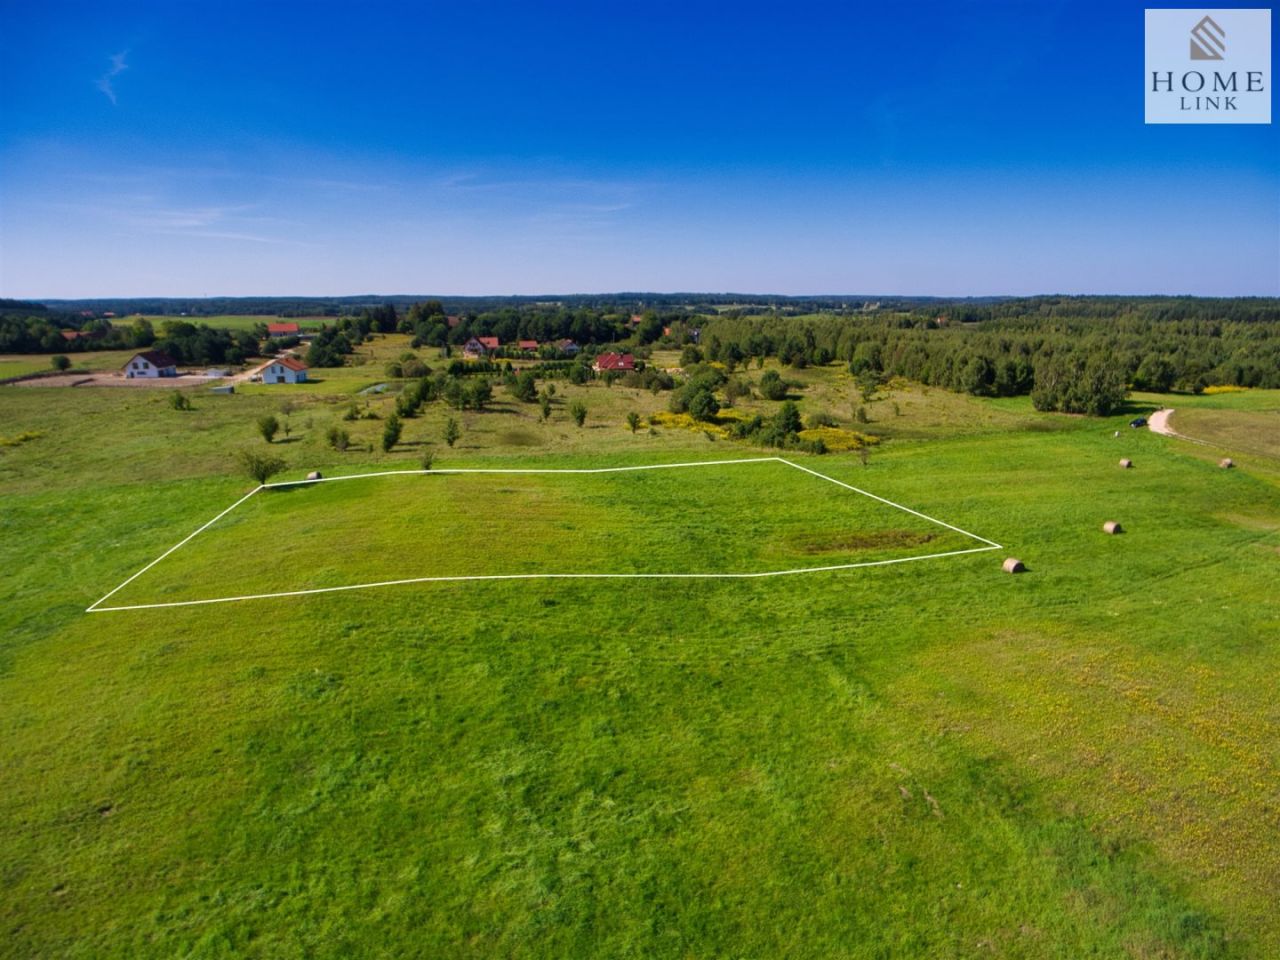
[{"x1": 0, "y1": 0, "x2": 1280, "y2": 297}]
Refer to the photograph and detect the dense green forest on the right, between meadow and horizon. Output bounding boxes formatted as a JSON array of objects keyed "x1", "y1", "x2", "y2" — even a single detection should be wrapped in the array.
[{"x1": 700, "y1": 298, "x2": 1280, "y2": 415}]
